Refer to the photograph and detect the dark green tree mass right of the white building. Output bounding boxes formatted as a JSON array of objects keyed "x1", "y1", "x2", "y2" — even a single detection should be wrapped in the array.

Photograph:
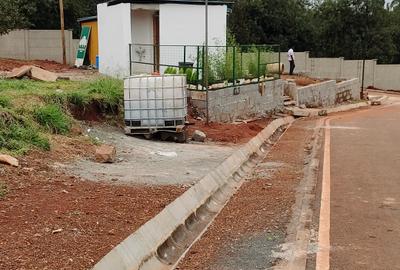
[{"x1": 229, "y1": 0, "x2": 400, "y2": 63}]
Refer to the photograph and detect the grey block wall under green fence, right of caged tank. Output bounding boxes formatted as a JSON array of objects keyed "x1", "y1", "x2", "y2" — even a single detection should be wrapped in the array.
[{"x1": 189, "y1": 80, "x2": 285, "y2": 122}]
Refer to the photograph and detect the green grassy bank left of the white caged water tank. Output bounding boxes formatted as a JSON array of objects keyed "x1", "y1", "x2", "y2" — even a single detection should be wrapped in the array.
[{"x1": 0, "y1": 77, "x2": 123, "y2": 155}]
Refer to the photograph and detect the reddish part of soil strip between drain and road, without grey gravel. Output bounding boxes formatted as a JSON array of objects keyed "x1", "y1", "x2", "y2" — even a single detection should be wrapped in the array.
[{"x1": 179, "y1": 121, "x2": 312, "y2": 270}]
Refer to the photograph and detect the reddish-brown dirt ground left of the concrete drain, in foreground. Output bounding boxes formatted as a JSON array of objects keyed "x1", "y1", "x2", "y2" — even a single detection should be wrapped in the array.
[{"x1": 0, "y1": 137, "x2": 185, "y2": 270}]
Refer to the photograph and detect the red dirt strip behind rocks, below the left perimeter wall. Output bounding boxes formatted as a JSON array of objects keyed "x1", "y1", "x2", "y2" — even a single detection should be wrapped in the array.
[{"x1": 0, "y1": 58, "x2": 78, "y2": 72}]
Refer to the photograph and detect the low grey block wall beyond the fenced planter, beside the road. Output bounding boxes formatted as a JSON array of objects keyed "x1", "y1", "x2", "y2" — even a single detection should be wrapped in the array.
[{"x1": 291, "y1": 78, "x2": 360, "y2": 108}]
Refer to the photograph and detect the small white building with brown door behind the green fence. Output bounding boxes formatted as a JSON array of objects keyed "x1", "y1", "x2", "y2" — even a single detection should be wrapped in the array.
[{"x1": 97, "y1": 0, "x2": 227, "y2": 77}]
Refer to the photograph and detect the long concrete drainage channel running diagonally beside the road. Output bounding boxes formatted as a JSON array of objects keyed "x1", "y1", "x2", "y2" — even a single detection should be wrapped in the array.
[{"x1": 93, "y1": 117, "x2": 294, "y2": 270}]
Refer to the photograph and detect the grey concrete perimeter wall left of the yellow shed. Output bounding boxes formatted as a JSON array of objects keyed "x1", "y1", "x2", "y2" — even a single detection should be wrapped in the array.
[{"x1": 0, "y1": 30, "x2": 79, "y2": 65}]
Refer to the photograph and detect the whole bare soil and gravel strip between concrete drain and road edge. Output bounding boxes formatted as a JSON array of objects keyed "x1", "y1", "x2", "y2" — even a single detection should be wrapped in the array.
[{"x1": 179, "y1": 121, "x2": 312, "y2": 270}]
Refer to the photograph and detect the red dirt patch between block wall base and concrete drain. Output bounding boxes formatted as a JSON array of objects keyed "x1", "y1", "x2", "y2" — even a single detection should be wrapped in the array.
[{"x1": 189, "y1": 118, "x2": 272, "y2": 144}]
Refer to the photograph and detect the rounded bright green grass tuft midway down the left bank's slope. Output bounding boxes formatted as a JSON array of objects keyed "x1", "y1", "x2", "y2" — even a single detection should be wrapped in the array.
[{"x1": 33, "y1": 104, "x2": 71, "y2": 134}]
